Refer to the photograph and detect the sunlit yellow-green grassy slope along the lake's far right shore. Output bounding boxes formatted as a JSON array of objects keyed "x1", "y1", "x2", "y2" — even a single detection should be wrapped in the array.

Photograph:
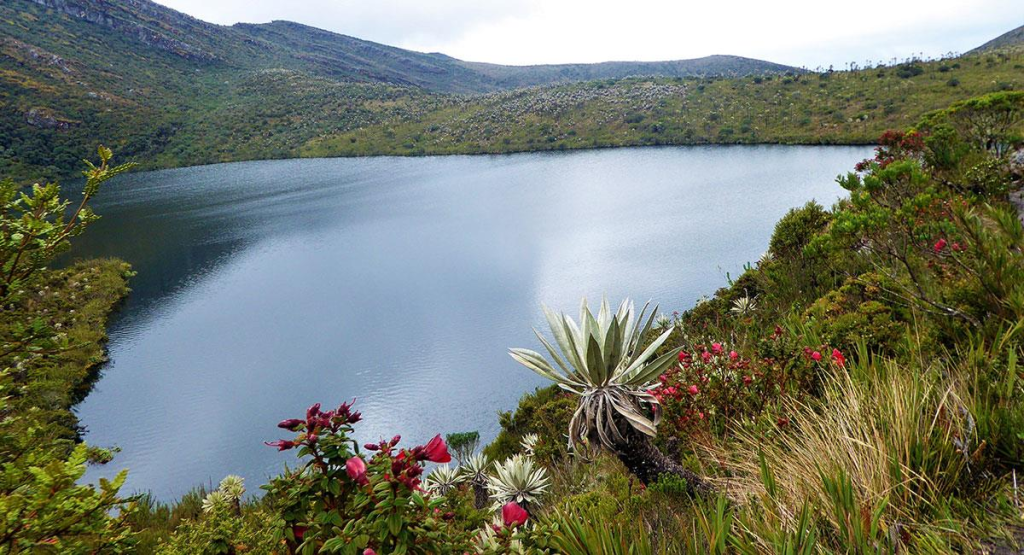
[{"x1": 301, "y1": 50, "x2": 1024, "y2": 157}]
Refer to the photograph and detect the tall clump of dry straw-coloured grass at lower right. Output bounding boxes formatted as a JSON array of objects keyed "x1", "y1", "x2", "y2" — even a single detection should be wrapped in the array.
[{"x1": 715, "y1": 356, "x2": 981, "y2": 552}]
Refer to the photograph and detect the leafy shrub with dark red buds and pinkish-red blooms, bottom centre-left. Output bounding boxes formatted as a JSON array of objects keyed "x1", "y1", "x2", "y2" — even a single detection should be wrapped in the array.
[{"x1": 264, "y1": 403, "x2": 470, "y2": 554}]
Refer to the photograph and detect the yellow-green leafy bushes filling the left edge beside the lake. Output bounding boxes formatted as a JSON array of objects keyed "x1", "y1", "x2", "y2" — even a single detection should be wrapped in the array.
[{"x1": 0, "y1": 153, "x2": 134, "y2": 553}]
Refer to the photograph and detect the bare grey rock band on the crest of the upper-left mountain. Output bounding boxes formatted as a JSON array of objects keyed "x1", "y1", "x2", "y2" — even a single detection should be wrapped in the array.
[{"x1": 25, "y1": 0, "x2": 216, "y2": 61}]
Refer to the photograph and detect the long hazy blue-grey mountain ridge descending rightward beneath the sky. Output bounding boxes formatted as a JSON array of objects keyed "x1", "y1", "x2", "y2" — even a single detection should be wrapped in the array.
[{"x1": 15, "y1": 0, "x2": 801, "y2": 93}]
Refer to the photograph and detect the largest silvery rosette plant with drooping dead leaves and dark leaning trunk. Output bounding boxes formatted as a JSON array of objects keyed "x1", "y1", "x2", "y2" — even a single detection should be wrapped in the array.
[{"x1": 511, "y1": 299, "x2": 711, "y2": 490}]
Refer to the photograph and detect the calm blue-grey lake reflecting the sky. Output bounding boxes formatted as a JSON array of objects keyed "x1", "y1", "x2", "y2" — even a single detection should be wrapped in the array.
[{"x1": 74, "y1": 146, "x2": 870, "y2": 500}]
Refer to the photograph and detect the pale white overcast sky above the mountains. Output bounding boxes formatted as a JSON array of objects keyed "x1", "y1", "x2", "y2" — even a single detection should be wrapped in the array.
[{"x1": 157, "y1": 0, "x2": 1024, "y2": 68}]
